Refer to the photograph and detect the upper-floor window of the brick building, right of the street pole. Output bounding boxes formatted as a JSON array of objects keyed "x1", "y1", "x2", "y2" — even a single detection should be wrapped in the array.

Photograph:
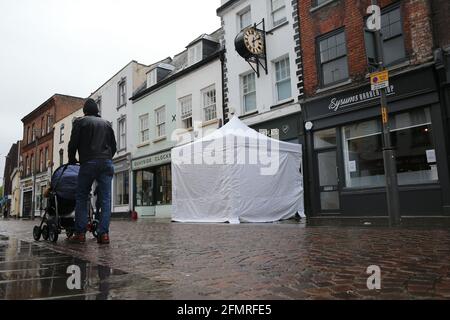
[{"x1": 381, "y1": 7, "x2": 406, "y2": 65}]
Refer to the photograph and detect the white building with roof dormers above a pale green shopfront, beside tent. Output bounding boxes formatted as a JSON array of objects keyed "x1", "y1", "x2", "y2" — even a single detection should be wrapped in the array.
[{"x1": 132, "y1": 29, "x2": 223, "y2": 218}]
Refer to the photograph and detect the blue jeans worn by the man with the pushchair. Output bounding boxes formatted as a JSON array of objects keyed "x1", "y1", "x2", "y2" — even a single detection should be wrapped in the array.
[{"x1": 75, "y1": 159, "x2": 114, "y2": 235}]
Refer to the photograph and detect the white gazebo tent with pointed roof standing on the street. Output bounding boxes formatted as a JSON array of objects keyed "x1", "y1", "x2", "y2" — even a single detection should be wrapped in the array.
[{"x1": 172, "y1": 117, "x2": 304, "y2": 223}]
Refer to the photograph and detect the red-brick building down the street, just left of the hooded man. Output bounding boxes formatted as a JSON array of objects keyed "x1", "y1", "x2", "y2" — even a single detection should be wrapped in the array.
[{"x1": 21, "y1": 94, "x2": 85, "y2": 217}]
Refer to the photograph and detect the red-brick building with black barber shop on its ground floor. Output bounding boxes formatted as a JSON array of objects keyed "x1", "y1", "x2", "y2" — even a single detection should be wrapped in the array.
[{"x1": 298, "y1": 0, "x2": 450, "y2": 216}]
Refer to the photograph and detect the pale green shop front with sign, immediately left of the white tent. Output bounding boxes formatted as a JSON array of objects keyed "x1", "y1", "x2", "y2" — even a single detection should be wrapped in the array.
[{"x1": 132, "y1": 150, "x2": 172, "y2": 218}]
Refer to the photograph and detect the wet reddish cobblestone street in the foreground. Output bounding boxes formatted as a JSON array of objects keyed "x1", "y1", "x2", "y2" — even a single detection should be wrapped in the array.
[{"x1": 0, "y1": 220, "x2": 450, "y2": 300}]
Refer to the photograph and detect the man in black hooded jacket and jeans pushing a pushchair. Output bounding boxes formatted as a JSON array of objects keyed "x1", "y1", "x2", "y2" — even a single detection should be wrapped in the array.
[{"x1": 69, "y1": 99, "x2": 117, "y2": 244}]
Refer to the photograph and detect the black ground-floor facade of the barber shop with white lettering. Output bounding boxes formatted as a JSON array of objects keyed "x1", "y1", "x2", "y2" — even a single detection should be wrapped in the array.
[{"x1": 303, "y1": 66, "x2": 450, "y2": 217}]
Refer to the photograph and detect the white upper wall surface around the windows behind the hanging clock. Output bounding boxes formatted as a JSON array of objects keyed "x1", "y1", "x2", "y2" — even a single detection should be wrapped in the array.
[{"x1": 222, "y1": 0, "x2": 300, "y2": 125}]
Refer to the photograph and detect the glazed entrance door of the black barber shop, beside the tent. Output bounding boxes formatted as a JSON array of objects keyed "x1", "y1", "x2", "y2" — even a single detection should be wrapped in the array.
[{"x1": 316, "y1": 149, "x2": 340, "y2": 213}]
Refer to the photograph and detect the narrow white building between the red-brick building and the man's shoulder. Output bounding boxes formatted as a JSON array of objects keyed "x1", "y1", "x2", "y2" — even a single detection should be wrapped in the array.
[{"x1": 53, "y1": 108, "x2": 84, "y2": 172}]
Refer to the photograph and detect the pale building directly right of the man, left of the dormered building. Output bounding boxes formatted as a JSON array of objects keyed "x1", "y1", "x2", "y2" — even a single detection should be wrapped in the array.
[{"x1": 90, "y1": 61, "x2": 150, "y2": 216}]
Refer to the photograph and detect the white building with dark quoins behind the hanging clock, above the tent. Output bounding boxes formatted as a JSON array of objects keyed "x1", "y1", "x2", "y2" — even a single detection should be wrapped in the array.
[{"x1": 217, "y1": 0, "x2": 302, "y2": 143}]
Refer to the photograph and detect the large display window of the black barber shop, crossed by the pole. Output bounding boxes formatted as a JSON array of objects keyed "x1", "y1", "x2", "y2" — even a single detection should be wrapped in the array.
[{"x1": 342, "y1": 108, "x2": 438, "y2": 188}]
